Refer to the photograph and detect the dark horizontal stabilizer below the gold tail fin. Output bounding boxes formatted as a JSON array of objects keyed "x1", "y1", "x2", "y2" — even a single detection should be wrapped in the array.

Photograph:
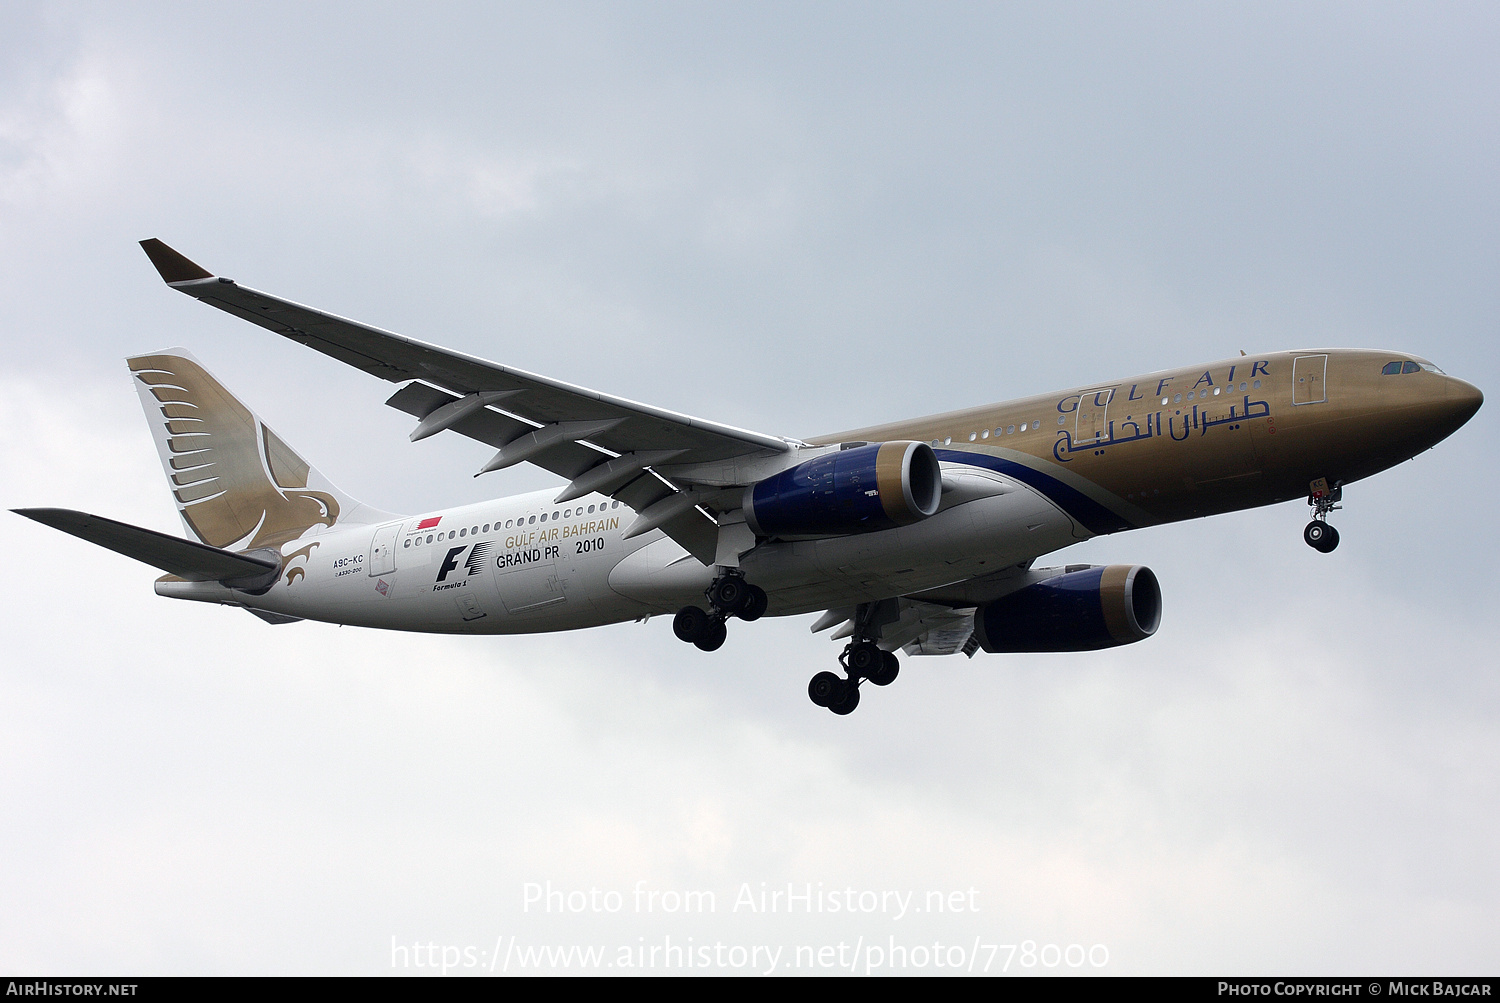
[{"x1": 12, "y1": 508, "x2": 281, "y2": 591}]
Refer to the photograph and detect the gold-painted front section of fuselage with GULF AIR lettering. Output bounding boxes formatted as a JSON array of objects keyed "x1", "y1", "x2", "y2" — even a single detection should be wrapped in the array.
[{"x1": 812, "y1": 349, "x2": 1484, "y2": 532}]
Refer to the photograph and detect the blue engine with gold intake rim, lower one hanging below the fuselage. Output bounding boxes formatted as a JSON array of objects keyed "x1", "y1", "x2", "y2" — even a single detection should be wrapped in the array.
[{"x1": 974, "y1": 564, "x2": 1161, "y2": 652}]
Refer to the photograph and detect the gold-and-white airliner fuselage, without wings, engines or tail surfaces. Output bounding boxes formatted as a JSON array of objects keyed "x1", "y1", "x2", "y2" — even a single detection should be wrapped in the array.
[{"x1": 158, "y1": 349, "x2": 1482, "y2": 634}]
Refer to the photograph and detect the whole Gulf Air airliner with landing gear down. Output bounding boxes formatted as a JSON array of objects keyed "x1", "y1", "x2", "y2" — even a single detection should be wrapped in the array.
[{"x1": 15, "y1": 238, "x2": 1484, "y2": 715}]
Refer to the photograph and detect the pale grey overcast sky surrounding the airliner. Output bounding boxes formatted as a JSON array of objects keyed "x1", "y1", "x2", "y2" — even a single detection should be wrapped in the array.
[{"x1": 0, "y1": 3, "x2": 1500, "y2": 975}]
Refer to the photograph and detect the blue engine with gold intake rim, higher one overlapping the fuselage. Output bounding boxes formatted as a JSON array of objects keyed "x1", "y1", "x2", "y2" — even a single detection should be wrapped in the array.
[{"x1": 744, "y1": 442, "x2": 942, "y2": 538}]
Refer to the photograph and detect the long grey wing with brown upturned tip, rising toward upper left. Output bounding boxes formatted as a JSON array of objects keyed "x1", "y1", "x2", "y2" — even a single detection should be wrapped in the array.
[{"x1": 141, "y1": 238, "x2": 795, "y2": 564}]
